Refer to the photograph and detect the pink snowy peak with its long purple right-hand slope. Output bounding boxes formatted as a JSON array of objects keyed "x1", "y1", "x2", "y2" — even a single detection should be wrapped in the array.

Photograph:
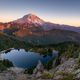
[{"x1": 13, "y1": 14, "x2": 80, "y2": 32}]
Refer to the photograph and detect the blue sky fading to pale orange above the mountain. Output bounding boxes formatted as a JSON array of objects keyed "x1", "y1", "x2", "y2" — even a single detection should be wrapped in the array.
[{"x1": 0, "y1": 0, "x2": 80, "y2": 26}]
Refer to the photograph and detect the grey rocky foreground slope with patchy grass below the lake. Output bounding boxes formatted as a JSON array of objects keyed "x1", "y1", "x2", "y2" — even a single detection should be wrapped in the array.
[{"x1": 0, "y1": 58, "x2": 80, "y2": 80}]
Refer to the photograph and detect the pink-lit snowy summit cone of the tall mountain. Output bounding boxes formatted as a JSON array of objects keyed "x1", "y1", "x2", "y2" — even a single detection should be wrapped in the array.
[{"x1": 15, "y1": 13, "x2": 44, "y2": 24}]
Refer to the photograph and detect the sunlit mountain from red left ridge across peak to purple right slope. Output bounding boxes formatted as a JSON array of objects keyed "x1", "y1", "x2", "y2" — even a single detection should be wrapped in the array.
[{"x1": 0, "y1": 14, "x2": 80, "y2": 33}]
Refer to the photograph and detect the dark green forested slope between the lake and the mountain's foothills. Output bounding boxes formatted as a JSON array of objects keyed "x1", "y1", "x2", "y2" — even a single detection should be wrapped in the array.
[{"x1": 0, "y1": 32, "x2": 80, "y2": 59}]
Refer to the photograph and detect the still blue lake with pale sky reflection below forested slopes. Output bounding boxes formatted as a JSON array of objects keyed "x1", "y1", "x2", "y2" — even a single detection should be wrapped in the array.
[{"x1": 1, "y1": 49, "x2": 55, "y2": 68}]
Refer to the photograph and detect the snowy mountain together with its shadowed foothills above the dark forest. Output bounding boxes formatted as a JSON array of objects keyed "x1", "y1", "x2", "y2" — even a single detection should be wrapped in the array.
[{"x1": 0, "y1": 14, "x2": 80, "y2": 44}]
